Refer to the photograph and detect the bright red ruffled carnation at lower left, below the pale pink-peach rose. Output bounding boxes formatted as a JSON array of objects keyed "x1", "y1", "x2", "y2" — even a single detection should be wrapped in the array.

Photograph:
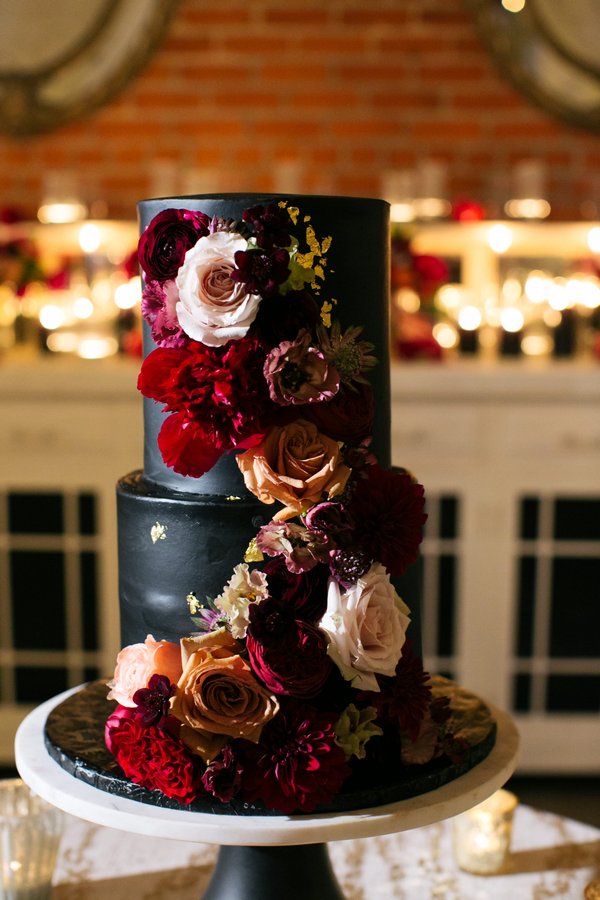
[{"x1": 105, "y1": 706, "x2": 202, "y2": 804}]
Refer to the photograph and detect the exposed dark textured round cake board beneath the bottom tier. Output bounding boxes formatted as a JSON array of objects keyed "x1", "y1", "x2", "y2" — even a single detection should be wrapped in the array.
[{"x1": 45, "y1": 681, "x2": 495, "y2": 816}]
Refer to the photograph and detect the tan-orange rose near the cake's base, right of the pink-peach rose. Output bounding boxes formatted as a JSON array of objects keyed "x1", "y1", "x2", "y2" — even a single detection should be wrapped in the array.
[{"x1": 171, "y1": 628, "x2": 279, "y2": 763}]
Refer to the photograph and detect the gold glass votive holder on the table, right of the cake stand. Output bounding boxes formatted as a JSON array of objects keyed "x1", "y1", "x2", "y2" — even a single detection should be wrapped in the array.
[{"x1": 452, "y1": 790, "x2": 518, "y2": 875}]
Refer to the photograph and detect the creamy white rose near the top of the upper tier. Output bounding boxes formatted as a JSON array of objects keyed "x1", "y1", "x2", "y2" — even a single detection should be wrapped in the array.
[{"x1": 176, "y1": 231, "x2": 260, "y2": 347}]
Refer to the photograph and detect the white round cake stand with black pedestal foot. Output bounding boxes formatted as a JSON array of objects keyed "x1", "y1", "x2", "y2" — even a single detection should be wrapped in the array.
[{"x1": 15, "y1": 688, "x2": 519, "y2": 900}]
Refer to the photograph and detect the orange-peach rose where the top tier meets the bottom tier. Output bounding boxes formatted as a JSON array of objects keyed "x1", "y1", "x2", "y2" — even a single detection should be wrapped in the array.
[{"x1": 236, "y1": 419, "x2": 350, "y2": 521}]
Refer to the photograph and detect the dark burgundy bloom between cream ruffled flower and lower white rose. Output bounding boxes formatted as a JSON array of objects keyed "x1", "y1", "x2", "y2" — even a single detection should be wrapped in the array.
[{"x1": 263, "y1": 556, "x2": 329, "y2": 624}]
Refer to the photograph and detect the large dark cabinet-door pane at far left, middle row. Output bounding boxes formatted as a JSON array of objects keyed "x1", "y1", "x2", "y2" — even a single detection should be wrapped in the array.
[{"x1": 10, "y1": 550, "x2": 66, "y2": 650}]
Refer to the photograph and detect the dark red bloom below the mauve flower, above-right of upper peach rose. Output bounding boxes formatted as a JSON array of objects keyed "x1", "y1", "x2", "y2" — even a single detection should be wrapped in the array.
[{"x1": 302, "y1": 384, "x2": 375, "y2": 445}]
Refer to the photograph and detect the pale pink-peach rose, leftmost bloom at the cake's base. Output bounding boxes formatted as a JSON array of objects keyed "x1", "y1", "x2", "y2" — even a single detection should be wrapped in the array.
[{"x1": 108, "y1": 634, "x2": 182, "y2": 707}]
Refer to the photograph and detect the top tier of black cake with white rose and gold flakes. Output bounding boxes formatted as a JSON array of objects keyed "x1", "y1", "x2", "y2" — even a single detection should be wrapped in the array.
[{"x1": 139, "y1": 194, "x2": 390, "y2": 496}]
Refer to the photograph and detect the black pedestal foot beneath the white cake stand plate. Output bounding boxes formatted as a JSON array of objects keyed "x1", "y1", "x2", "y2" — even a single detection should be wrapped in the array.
[{"x1": 202, "y1": 844, "x2": 344, "y2": 900}]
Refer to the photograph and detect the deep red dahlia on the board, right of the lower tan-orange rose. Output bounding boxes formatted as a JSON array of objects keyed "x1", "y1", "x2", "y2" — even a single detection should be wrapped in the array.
[{"x1": 242, "y1": 701, "x2": 350, "y2": 814}]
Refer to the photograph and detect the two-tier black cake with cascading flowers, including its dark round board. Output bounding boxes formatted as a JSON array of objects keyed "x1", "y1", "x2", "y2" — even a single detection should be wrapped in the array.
[{"x1": 42, "y1": 194, "x2": 494, "y2": 815}]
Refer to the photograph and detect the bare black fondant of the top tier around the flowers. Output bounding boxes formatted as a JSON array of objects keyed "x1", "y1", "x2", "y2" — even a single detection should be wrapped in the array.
[{"x1": 138, "y1": 194, "x2": 390, "y2": 495}]
